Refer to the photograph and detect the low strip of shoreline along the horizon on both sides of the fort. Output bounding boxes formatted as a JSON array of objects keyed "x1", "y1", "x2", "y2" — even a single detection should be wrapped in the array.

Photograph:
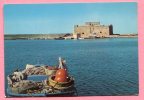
[{"x1": 4, "y1": 33, "x2": 138, "y2": 40}]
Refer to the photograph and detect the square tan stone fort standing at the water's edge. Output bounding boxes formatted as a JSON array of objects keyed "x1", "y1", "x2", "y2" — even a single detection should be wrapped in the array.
[{"x1": 73, "y1": 22, "x2": 113, "y2": 39}]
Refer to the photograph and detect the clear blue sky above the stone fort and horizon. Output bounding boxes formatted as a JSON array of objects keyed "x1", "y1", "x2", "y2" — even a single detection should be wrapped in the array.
[{"x1": 4, "y1": 2, "x2": 138, "y2": 34}]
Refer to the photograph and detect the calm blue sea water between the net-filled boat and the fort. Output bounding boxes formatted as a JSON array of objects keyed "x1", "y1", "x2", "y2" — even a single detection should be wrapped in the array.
[{"x1": 5, "y1": 38, "x2": 138, "y2": 96}]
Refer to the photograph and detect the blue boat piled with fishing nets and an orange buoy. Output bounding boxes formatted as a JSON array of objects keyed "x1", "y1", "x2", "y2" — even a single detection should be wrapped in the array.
[{"x1": 7, "y1": 57, "x2": 78, "y2": 97}]
